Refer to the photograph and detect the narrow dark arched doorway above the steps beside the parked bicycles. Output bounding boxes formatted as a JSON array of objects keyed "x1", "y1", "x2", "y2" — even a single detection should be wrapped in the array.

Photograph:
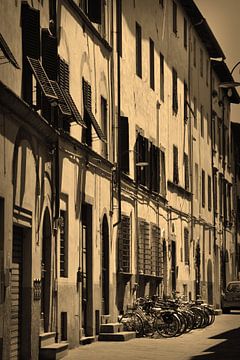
[{"x1": 101, "y1": 215, "x2": 109, "y2": 315}]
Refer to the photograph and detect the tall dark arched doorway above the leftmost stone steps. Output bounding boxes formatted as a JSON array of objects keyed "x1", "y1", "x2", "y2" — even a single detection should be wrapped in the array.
[{"x1": 41, "y1": 209, "x2": 52, "y2": 332}]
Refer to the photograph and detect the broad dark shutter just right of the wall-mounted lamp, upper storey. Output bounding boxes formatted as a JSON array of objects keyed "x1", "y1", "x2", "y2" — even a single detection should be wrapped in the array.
[{"x1": 149, "y1": 143, "x2": 160, "y2": 193}]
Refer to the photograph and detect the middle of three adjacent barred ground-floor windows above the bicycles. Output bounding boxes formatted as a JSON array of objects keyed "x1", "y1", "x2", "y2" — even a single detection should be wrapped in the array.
[{"x1": 137, "y1": 219, "x2": 149, "y2": 275}]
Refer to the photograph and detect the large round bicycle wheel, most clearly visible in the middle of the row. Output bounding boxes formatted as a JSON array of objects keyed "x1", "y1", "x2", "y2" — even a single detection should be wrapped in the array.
[{"x1": 154, "y1": 311, "x2": 180, "y2": 337}]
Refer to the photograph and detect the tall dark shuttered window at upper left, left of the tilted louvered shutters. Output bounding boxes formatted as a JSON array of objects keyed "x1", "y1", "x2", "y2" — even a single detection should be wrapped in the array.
[{"x1": 21, "y1": 3, "x2": 41, "y2": 109}]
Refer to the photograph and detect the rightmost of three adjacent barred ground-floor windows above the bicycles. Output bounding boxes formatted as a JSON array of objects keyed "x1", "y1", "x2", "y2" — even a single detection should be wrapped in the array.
[{"x1": 151, "y1": 225, "x2": 163, "y2": 277}]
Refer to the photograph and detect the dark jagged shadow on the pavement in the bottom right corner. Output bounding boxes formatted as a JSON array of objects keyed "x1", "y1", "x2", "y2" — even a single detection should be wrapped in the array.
[{"x1": 191, "y1": 324, "x2": 240, "y2": 360}]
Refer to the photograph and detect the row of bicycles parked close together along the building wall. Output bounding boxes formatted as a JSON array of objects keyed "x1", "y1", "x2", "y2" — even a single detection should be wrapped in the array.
[{"x1": 119, "y1": 295, "x2": 215, "y2": 337}]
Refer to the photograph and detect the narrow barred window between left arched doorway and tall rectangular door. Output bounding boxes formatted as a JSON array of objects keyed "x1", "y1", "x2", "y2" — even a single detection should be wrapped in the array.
[{"x1": 60, "y1": 210, "x2": 68, "y2": 277}]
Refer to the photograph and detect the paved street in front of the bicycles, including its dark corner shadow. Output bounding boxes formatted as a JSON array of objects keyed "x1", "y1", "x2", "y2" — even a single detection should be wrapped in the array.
[{"x1": 64, "y1": 312, "x2": 240, "y2": 360}]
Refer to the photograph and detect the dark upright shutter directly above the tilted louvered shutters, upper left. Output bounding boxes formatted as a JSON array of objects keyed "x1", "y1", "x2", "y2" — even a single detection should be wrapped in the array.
[{"x1": 42, "y1": 29, "x2": 57, "y2": 81}]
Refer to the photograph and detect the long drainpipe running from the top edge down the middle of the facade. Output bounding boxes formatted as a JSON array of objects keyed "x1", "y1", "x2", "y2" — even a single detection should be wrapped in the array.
[{"x1": 113, "y1": 0, "x2": 122, "y2": 227}]
